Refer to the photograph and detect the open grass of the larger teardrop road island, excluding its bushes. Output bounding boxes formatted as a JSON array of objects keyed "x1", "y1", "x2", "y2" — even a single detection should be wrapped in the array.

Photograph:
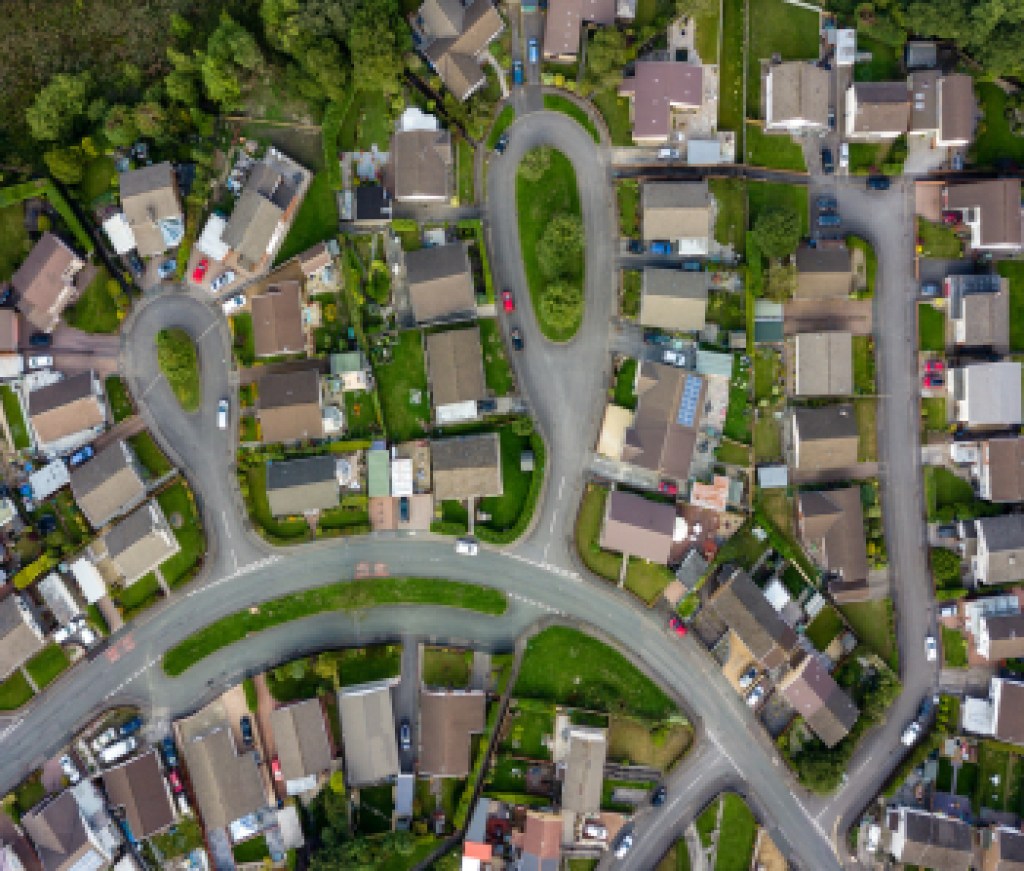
[{"x1": 515, "y1": 149, "x2": 585, "y2": 342}]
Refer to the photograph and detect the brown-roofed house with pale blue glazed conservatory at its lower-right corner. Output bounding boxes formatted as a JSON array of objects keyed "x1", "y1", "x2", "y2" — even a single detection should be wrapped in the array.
[{"x1": 119, "y1": 161, "x2": 184, "y2": 257}]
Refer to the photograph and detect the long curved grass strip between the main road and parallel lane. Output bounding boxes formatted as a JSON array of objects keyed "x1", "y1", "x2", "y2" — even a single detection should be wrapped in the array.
[{"x1": 163, "y1": 577, "x2": 508, "y2": 677}]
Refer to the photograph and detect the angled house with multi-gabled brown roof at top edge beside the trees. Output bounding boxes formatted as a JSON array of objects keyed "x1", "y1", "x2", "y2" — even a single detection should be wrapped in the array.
[{"x1": 413, "y1": 0, "x2": 505, "y2": 100}]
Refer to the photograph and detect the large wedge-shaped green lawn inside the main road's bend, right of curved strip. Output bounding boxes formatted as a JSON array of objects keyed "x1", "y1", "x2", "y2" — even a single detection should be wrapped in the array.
[{"x1": 515, "y1": 626, "x2": 676, "y2": 720}]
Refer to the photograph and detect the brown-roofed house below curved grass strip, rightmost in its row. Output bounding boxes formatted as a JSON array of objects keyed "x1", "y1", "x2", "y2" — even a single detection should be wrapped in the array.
[{"x1": 418, "y1": 690, "x2": 487, "y2": 778}]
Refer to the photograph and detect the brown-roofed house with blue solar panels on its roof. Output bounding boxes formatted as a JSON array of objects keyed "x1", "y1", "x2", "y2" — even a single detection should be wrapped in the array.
[{"x1": 621, "y1": 362, "x2": 707, "y2": 482}]
